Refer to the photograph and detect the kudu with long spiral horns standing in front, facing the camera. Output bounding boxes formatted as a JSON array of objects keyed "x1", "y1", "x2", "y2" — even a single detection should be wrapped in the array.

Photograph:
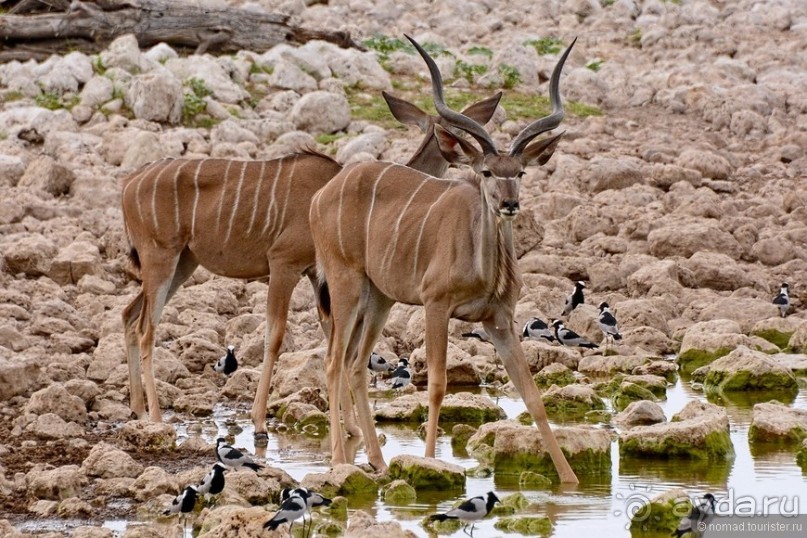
[{"x1": 311, "y1": 38, "x2": 577, "y2": 483}]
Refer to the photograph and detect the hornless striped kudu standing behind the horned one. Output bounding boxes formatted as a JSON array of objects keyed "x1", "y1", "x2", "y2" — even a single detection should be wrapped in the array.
[{"x1": 122, "y1": 93, "x2": 501, "y2": 435}]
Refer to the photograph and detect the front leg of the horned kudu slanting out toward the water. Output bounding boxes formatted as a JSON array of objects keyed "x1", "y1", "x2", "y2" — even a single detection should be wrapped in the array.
[{"x1": 483, "y1": 320, "x2": 578, "y2": 484}]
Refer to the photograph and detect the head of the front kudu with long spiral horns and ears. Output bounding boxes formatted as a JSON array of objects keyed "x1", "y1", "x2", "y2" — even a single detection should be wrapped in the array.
[{"x1": 406, "y1": 36, "x2": 577, "y2": 220}]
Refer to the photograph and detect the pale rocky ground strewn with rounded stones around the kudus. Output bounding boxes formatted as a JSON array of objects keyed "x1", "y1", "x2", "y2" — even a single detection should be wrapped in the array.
[{"x1": 0, "y1": 0, "x2": 807, "y2": 536}]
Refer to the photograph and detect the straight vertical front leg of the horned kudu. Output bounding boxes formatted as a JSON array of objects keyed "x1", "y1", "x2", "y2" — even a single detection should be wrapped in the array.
[{"x1": 425, "y1": 306, "x2": 448, "y2": 458}]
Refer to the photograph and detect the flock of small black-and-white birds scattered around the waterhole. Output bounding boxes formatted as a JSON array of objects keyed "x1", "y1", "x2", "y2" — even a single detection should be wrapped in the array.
[{"x1": 188, "y1": 281, "x2": 791, "y2": 538}]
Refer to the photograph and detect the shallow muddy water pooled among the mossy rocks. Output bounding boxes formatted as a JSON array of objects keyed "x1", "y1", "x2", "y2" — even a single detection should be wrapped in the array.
[{"x1": 106, "y1": 374, "x2": 807, "y2": 538}]
